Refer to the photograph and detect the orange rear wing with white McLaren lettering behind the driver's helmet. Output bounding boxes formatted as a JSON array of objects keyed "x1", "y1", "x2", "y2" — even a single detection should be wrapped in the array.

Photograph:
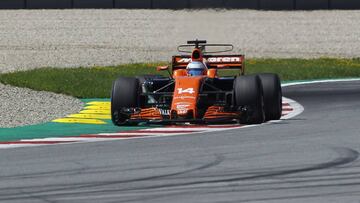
[{"x1": 172, "y1": 55, "x2": 245, "y2": 75}]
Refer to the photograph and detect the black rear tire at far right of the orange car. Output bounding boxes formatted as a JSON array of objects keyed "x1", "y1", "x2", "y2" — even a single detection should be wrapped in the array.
[{"x1": 259, "y1": 73, "x2": 282, "y2": 121}]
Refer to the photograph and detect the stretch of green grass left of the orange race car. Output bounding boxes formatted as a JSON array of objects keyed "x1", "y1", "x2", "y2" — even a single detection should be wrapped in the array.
[{"x1": 0, "y1": 64, "x2": 164, "y2": 98}]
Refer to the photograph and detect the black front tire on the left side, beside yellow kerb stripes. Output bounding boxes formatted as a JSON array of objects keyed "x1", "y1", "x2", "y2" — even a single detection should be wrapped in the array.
[{"x1": 111, "y1": 77, "x2": 139, "y2": 126}]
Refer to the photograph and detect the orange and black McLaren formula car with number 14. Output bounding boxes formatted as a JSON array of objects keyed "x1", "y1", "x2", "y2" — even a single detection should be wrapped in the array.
[{"x1": 111, "y1": 40, "x2": 282, "y2": 126}]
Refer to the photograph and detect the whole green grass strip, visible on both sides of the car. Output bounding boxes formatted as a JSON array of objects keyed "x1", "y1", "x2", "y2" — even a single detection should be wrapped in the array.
[{"x1": 0, "y1": 58, "x2": 360, "y2": 98}]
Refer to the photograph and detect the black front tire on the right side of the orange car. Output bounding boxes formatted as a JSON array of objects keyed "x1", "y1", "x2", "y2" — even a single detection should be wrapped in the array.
[{"x1": 234, "y1": 75, "x2": 265, "y2": 124}]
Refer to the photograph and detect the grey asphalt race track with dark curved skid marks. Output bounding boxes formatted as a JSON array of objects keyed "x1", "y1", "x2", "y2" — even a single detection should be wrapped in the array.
[{"x1": 0, "y1": 81, "x2": 360, "y2": 203}]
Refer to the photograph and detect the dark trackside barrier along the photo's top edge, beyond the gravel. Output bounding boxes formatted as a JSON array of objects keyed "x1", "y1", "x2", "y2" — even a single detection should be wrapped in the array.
[{"x1": 0, "y1": 0, "x2": 360, "y2": 10}]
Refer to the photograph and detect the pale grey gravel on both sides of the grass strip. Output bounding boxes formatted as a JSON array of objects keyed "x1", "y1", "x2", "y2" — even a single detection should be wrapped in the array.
[{"x1": 0, "y1": 10, "x2": 360, "y2": 127}]
